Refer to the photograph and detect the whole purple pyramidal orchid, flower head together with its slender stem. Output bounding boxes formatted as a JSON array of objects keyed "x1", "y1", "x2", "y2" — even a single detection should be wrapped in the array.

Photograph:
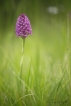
[{"x1": 15, "y1": 14, "x2": 32, "y2": 78}]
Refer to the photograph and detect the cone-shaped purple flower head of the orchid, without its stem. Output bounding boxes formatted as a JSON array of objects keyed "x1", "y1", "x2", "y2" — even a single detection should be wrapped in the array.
[{"x1": 16, "y1": 14, "x2": 32, "y2": 37}]
